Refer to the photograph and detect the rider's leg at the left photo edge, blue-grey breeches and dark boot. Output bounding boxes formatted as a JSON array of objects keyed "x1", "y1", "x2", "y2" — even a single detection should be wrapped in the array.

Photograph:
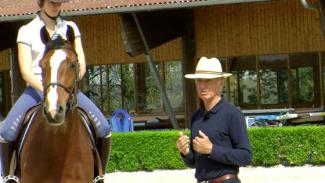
[{"x1": 0, "y1": 87, "x2": 42, "y2": 176}]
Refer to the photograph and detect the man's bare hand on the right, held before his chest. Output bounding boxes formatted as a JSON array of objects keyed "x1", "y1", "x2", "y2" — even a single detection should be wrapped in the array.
[{"x1": 193, "y1": 130, "x2": 213, "y2": 154}]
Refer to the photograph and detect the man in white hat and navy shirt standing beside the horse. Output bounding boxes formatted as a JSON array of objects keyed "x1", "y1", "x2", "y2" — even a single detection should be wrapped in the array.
[{"x1": 177, "y1": 57, "x2": 252, "y2": 183}]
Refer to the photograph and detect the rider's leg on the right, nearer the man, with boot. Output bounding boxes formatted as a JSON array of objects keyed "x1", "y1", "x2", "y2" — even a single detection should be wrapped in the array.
[{"x1": 77, "y1": 92, "x2": 111, "y2": 173}]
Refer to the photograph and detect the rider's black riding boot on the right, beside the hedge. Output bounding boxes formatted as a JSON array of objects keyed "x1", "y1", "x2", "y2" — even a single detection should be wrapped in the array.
[{"x1": 97, "y1": 133, "x2": 112, "y2": 174}]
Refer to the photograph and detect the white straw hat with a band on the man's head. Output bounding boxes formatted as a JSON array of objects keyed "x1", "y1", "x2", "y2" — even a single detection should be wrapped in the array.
[{"x1": 185, "y1": 57, "x2": 232, "y2": 79}]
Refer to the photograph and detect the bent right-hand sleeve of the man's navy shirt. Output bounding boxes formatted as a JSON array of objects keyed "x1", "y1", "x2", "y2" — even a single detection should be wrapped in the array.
[{"x1": 210, "y1": 112, "x2": 252, "y2": 166}]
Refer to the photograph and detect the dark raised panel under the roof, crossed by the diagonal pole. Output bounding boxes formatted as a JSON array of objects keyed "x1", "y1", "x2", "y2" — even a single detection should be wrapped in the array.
[{"x1": 120, "y1": 10, "x2": 188, "y2": 56}]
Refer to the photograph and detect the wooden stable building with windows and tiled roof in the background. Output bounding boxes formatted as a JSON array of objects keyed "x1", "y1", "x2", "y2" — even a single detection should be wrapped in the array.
[{"x1": 0, "y1": 0, "x2": 325, "y2": 128}]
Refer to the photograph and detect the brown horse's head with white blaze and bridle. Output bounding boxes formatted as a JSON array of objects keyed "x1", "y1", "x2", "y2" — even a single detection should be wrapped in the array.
[{"x1": 40, "y1": 26, "x2": 79, "y2": 125}]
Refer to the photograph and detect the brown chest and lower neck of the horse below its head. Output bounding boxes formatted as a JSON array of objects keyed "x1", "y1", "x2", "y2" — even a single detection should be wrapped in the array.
[{"x1": 20, "y1": 110, "x2": 94, "y2": 183}]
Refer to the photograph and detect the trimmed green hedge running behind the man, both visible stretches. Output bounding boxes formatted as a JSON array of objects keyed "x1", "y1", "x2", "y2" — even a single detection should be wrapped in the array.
[{"x1": 108, "y1": 126, "x2": 325, "y2": 172}]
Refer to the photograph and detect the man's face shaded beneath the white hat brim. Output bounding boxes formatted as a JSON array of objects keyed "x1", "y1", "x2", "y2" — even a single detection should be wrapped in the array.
[{"x1": 195, "y1": 78, "x2": 224, "y2": 101}]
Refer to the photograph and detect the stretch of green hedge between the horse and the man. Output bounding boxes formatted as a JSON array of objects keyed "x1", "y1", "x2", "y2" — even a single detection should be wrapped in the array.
[{"x1": 108, "y1": 131, "x2": 185, "y2": 171}]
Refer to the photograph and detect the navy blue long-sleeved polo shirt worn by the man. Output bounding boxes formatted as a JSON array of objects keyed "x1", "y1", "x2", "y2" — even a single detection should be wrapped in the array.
[{"x1": 183, "y1": 99, "x2": 252, "y2": 181}]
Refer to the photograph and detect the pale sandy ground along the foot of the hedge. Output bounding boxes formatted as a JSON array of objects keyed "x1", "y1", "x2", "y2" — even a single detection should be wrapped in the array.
[{"x1": 106, "y1": 166, "x2": 325, "y2": 183}]
